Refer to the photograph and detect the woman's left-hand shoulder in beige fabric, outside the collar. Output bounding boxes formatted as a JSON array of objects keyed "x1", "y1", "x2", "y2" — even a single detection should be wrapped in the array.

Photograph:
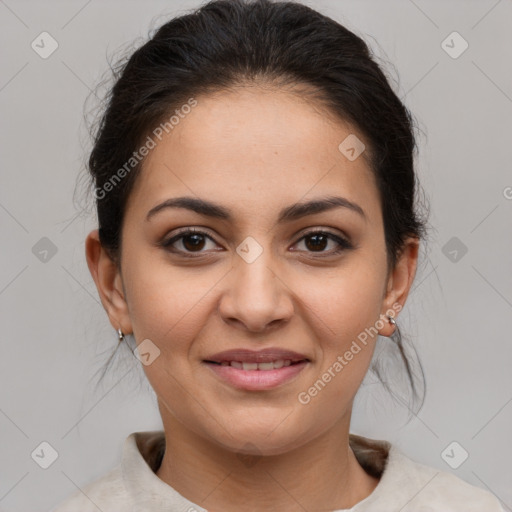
[{"x1": 51, "y1": 465, "x2": 130, "y2": 512}]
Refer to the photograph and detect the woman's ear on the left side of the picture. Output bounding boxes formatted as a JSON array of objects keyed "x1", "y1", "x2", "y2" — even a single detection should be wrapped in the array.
[{"x1": 85, "y1": 229, "x2": 133, "y2": 334}]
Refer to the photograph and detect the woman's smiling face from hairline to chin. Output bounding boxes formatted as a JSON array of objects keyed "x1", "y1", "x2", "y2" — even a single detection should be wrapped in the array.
[{"x1": 87, "y1": 88, "x2": 414, "y2": 454}]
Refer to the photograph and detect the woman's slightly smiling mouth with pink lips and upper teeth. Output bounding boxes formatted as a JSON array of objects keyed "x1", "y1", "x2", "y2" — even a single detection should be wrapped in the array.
[{"x1": 203, "y1": 348, "x2": 311, "y2": 391}]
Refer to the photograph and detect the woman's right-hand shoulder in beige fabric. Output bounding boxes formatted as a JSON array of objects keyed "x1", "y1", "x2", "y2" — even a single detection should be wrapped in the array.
[{"x1": 362, "y1": 445, "x2": 503, "y2": 512}]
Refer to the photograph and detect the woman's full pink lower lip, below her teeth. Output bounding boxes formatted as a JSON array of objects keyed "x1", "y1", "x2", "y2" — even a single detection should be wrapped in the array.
[{"x1": 205, "y1": 361, "x2": 308, "y2": 391}]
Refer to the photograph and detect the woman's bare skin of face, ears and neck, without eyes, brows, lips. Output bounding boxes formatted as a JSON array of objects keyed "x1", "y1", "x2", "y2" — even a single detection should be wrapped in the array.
[{"x1": 86, "y1": 87, "x2": 418, "y2": 512}]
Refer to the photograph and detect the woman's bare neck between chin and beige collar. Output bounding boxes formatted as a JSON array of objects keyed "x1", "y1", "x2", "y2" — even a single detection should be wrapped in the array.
[{"x1": 157, "y1": 416, "x2": 379, "y2": 512}]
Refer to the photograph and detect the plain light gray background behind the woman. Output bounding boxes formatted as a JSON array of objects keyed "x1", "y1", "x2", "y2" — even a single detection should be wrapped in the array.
[{"x1": 0, "y1": 0, "x2": 512, "y2": 512}]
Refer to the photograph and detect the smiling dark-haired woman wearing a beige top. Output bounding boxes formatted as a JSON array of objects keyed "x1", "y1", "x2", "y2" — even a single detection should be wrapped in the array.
[{"x1": 56, "y1": 0, "x2": 502, "y2": 512}]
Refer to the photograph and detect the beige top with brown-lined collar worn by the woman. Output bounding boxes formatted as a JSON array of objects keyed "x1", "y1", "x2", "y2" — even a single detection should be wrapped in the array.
[{"x1": 52, "y1": 430, "x2": 504, "y2": 512}]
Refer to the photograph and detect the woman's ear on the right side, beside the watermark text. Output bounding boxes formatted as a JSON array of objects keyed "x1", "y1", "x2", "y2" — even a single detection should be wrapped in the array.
[{"x1": 379, "y1": 237, "x2": 419, "y2": 337}]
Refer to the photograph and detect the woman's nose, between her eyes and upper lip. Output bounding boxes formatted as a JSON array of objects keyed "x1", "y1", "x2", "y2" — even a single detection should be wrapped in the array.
[{"x1": 219, "y1": 251, "x2": 294, "y2": 333}]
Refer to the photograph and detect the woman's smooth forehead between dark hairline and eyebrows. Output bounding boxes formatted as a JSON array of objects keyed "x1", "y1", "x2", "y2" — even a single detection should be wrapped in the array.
[{"x1": 124, "y1": 87, "x2": 378, "y2": 224}]
